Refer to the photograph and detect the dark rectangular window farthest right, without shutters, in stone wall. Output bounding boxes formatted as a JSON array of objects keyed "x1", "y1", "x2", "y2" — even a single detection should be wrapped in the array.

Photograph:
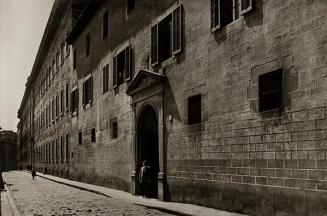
[{"x1": 259, "y1": 69, "x2": 283, "y2": 112}]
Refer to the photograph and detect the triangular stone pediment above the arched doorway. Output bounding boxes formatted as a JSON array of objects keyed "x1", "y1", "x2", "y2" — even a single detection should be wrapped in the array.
[{"x1": 126, "y1": 69, "x2": 166, "y2": 96}]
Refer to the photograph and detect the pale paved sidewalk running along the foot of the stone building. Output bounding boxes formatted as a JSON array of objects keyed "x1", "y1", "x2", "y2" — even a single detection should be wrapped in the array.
[{"x1": 37, "y1": 173, "x2": 244, "y2": 216}]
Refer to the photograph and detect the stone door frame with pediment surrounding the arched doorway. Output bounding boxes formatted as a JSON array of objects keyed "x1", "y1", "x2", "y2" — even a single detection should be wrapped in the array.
[{"x1": 126, "y1": 70, "x2": 166, "y2": 200}]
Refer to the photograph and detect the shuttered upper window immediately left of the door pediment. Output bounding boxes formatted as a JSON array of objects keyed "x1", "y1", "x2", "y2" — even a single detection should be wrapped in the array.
[{"x1": 112, "y1": 46, "x2": 132, "y2": 88}]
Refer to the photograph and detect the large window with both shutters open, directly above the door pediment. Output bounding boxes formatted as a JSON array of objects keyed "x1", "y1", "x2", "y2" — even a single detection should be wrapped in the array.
[{"x1": 151, "y1": 6, "x2": 182, "y2": 66}]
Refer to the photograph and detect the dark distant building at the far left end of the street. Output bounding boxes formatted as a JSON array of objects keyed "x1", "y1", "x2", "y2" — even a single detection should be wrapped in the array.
[{"x1": 0, "y1": 130, "x2": 17, "y2": 171}]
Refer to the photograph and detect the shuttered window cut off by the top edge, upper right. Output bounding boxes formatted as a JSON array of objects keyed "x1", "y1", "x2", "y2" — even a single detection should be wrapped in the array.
[{"x1": 211, "y1": 0, "x2": 253, "y2": 31}]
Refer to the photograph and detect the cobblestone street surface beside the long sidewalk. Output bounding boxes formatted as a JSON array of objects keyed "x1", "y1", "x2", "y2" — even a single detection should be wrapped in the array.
[{"x1": 3, "y1": 172, "x2": 177, "y2": 216}]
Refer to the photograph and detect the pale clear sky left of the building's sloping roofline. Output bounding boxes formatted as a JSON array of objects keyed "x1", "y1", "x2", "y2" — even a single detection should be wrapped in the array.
[{"x1": 0, "y1": 0, "x2": 54, "y2": 131}]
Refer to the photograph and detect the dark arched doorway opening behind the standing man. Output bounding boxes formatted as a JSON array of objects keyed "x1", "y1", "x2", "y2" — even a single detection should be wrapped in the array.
[{"x1": 137, "y1": 105, "x2": 159, "y2": 198}]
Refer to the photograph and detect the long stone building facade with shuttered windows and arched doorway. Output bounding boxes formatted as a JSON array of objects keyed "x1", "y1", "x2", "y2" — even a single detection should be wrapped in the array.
[{"x1": 21, "y1": 0, "x2": 327, "y2": 215}]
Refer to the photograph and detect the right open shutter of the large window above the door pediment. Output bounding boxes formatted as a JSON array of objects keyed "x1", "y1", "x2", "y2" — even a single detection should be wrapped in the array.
[{"x1": 172, "y1": 6, "x2": 182, "y2": 55}]
